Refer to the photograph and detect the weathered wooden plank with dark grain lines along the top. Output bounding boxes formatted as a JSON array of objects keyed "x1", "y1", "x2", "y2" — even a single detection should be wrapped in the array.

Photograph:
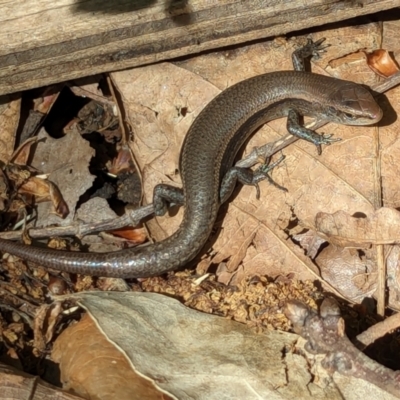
[{"x1": 0, "y1": 0, "x2": 400, "y2": 94}]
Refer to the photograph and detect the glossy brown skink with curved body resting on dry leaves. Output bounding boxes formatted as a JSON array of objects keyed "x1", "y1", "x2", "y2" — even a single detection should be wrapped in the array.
[{"x1": 0, "y1": 42, "x2": 382, "y2": 278}]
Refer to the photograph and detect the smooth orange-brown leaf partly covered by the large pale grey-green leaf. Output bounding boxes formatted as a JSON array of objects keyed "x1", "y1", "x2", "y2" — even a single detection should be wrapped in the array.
[{"x1": 52, "y1": 315, "x2": 168, "y2": 400}]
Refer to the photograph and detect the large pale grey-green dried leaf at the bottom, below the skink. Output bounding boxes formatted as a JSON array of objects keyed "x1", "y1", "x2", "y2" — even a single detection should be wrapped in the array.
[{"x1": 51, "y1": 292, "x2": 398, "y2": 400}]
